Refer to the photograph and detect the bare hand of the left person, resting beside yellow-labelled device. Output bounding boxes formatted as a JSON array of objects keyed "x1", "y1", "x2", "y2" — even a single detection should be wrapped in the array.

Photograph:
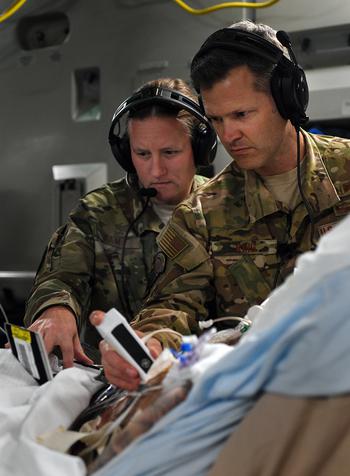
[{"x1": 29, "y1": 306, "x2": 93, "y2": 367}]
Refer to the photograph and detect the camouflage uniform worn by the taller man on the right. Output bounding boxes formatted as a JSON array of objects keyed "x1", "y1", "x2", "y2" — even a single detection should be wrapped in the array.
[{"x1": 133, "y1": 131, "x2": 350, "y2": 345}]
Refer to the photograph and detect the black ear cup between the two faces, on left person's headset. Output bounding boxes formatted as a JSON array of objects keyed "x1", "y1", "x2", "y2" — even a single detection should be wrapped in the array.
[{"x1": 192, "y1": 124, "x2": 217, "y2": 166}]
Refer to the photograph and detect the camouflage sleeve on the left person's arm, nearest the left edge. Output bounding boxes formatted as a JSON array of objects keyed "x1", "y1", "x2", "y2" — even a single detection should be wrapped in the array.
[{"x1": 24, "y1": 206, "x2": 94, "y2": 329}]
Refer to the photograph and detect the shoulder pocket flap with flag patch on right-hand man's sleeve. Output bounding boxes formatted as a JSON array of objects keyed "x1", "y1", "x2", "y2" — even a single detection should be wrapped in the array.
[{"x1": 158, "y1": 223, "x2": 209, "y2": 271}]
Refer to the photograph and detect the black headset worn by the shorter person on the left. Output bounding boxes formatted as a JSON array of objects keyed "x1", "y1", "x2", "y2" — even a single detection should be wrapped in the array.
[{"x1": 108, "y1": 87, "x2": 217, "y2": 173}]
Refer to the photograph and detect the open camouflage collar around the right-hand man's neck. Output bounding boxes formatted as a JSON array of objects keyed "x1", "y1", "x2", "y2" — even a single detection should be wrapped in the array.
[{"x1": 244, "y1": 131, "x2": 340, "y2": 223}]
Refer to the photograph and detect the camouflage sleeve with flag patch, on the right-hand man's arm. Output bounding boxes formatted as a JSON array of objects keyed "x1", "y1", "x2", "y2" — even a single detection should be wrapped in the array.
[{"x1": 133, "y1": 204, "x2": 215, "y2": 347}]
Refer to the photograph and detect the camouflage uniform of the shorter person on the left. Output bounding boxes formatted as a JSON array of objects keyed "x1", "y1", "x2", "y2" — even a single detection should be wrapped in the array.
[{"x1": 24, "y1": 176, "x2": 207, "y2": 354}]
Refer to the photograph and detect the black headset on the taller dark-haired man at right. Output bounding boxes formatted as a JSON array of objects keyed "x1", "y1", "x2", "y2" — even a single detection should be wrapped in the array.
[{"x1": 192, "y1": 28, "x2": 309, "y2": 127}]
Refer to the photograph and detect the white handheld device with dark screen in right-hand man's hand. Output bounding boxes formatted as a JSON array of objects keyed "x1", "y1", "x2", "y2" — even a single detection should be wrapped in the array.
[{"x1": 96, "y1": 308, "x2": 154, "y2": 380}]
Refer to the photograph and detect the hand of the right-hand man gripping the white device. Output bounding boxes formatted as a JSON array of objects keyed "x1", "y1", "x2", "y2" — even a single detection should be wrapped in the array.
[{"x1": 90, "y1": 311, "x2": 162, "y2": 390}]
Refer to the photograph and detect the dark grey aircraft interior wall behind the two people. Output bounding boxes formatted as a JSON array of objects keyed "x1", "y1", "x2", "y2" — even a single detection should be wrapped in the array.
[{"x1": 0, "y1": 0, "x2": 350, "y2": 326}]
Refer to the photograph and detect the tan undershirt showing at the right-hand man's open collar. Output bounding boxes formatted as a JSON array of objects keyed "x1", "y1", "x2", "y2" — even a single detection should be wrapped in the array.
[{"x1": 262, "y1": 160, "x2": 306, "y2": 210}]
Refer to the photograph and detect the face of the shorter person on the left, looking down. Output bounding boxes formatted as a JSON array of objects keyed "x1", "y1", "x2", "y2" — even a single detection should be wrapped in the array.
[{"x1": 128, "y1": 117, "x2": 196, "y2": 204}]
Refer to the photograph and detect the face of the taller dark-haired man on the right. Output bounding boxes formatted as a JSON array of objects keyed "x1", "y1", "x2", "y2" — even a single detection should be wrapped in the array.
[{"x1": 201, "y1": 66, "x2": 296, "y2": 175}]
